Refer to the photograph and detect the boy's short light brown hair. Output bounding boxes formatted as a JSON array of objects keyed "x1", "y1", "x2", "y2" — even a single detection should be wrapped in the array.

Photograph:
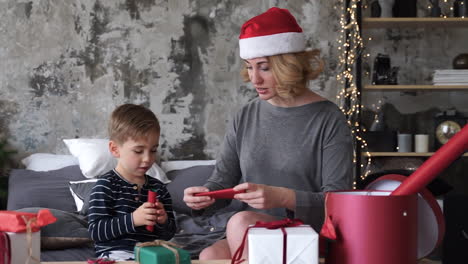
[{"x1": 108, "y1": 104, "x2": 161, "y2": 144}]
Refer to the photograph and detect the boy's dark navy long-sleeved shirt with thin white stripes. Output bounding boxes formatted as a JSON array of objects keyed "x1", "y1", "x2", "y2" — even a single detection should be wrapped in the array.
[{"x1": 88, "y1": 170, "x2": 176, "y2": 256}]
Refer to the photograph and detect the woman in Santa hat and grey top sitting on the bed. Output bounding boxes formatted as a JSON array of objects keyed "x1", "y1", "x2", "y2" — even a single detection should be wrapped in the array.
[{"x1": 184, "y1": 8, "x2": 353, "y2": 259}]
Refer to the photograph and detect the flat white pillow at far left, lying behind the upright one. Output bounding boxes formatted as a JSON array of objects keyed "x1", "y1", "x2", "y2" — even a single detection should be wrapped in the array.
[{"x1": 21, "y1": 153, "x2": 78, "y2": 171}]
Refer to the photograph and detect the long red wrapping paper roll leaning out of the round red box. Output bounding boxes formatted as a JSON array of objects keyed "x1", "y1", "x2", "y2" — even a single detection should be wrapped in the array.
[{"x1": 391, "y1": 125, "x2": 468, "y2": 195}]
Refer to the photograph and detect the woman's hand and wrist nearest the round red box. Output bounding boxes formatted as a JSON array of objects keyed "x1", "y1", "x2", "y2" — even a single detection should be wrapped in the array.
[{"x1": 234, "y1": 182, "x2": 296, "y2": 211}]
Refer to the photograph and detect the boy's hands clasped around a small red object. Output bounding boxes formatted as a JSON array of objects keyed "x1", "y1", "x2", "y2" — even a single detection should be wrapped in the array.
[{"x1": 132, "y1": 200, "x2": 167, "y2": 226}]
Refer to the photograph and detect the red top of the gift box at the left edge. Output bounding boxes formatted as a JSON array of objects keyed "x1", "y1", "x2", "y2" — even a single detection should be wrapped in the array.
[{"x1": 0, "y1": 209, "x2": 57, "y2": 233}]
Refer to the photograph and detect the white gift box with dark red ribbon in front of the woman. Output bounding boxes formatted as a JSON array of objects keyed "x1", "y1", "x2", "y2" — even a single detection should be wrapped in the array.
[{"x1": 248, "y1": 225, "x2": 319, "y2": 264}]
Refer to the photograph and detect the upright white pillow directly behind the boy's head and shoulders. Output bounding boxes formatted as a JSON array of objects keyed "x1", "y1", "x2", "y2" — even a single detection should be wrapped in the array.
[{"x1": 63, "y1": 138, "x2": 170, "y2": 183}]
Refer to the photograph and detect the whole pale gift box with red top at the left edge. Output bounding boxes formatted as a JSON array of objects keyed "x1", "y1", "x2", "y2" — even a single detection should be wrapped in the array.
[{"x1": 0, "y1": 209, "x2": 57, "y2": 264}]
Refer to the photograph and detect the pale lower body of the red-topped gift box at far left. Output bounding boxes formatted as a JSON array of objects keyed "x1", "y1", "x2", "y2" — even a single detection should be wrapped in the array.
[{"x1": 6, "y1": 231, "x2": 41, "y2": 264}]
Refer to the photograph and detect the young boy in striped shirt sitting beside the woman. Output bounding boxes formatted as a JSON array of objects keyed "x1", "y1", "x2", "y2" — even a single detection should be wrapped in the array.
[{"x1": 88, "y1": 104, "x2": 176, "y2": 260}]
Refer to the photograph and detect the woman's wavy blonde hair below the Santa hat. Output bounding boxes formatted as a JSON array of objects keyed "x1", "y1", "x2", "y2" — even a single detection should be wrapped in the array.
[{"x1": 241, "y1": 49, "x2": 324, "y2": 98}]
